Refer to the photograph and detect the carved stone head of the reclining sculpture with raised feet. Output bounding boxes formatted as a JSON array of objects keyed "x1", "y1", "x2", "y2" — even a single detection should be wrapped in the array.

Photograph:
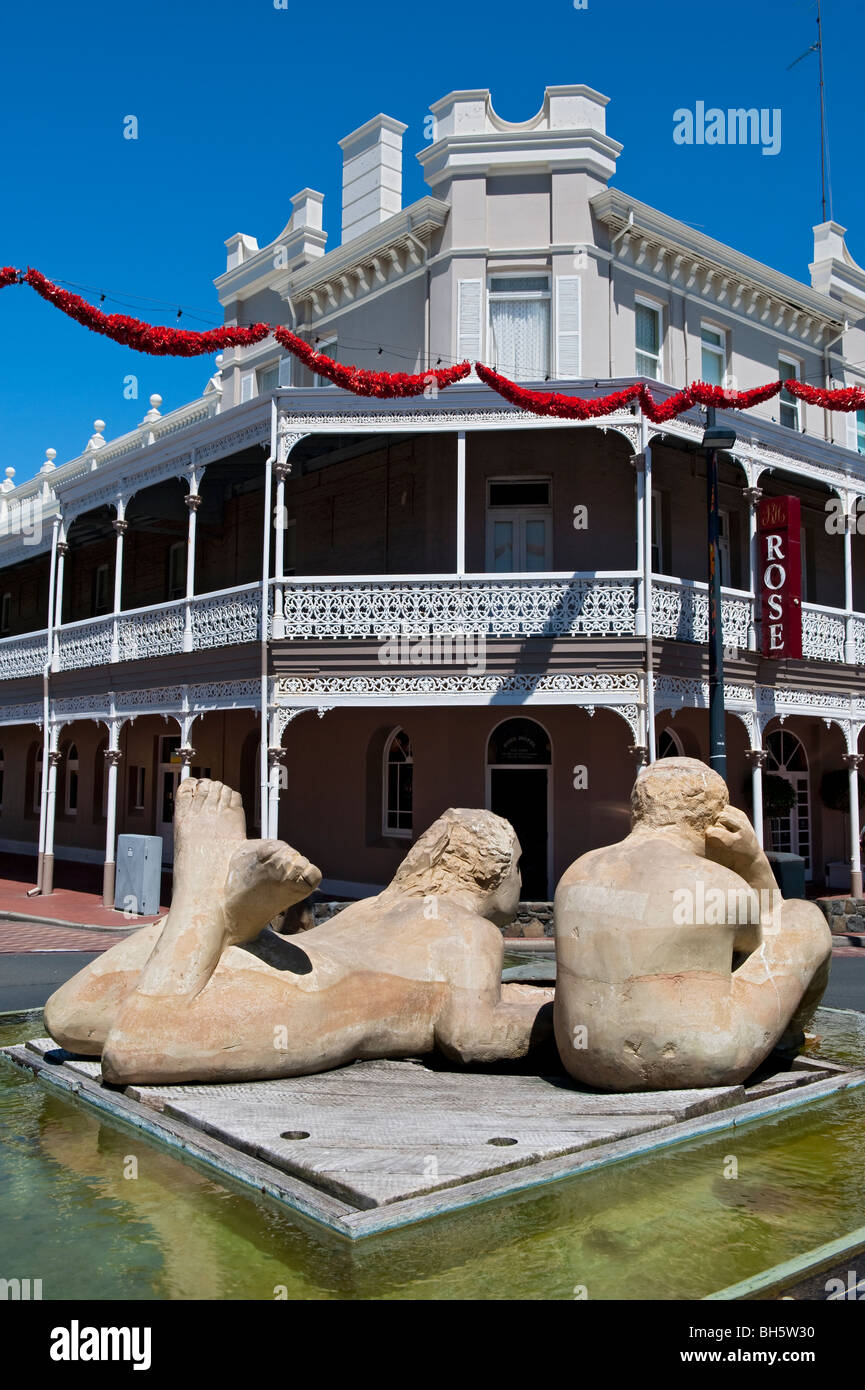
[{"x1": 391, "y1": 808, "x2": 520, "y2": 926}]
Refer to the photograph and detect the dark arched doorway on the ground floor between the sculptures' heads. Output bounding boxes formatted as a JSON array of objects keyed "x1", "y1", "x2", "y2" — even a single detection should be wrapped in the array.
[{"x1": 487, "y1": 719, "x2": 552, "y2": 901}]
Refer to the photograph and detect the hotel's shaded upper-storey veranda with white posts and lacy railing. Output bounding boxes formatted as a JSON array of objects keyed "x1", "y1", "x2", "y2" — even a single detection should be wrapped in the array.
[{"x1": 0, "y1": 384, "x2": 865, "y2": 681}]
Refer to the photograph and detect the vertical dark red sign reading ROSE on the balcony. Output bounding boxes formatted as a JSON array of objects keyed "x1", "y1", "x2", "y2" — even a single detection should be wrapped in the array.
[{"x1": 759, "y1": 498, "x2": 802, "y2": 662}]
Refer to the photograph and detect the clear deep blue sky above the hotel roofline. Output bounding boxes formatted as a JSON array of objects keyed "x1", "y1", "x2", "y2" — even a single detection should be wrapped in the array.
[{"x1": 0, "y1": 0, "x2": 865, "y2": 481}]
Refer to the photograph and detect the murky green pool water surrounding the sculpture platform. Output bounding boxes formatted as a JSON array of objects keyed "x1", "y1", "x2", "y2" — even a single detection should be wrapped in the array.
[{"x1": 0, "y1": 1011, "x2": 865, "y2": 1300}]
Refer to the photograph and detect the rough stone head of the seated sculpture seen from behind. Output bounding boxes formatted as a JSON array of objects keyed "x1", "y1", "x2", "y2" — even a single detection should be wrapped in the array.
[{"x1": 631, "y1": 758, "x2": 730, "y2": 835}]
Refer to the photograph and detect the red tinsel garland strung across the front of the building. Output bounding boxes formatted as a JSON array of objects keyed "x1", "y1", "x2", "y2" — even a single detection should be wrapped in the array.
[{"x1": 0, "y1": 265, "x2": 865, "y2": 424}]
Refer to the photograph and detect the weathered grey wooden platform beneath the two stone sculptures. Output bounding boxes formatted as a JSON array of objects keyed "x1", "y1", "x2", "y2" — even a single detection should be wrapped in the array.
[{"x1": 0, "y1": 1038, "x2": 865, "y2": 1237}]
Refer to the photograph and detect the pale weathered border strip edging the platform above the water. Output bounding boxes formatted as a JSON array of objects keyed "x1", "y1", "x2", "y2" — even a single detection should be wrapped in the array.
[{"x1": 0, "y1": 1045, "x2": 865, "y2": 1245}]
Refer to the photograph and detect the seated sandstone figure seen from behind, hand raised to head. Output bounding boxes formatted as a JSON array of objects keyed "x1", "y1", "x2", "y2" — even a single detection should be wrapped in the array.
[{"x1": 555, "y1": 758, "x2": 832, "y2": 1091}]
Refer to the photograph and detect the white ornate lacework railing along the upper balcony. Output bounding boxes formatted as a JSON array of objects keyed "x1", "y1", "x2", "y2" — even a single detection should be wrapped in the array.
[{"x1": 0, "y1": 573, "x2": 865, "y2": 680}]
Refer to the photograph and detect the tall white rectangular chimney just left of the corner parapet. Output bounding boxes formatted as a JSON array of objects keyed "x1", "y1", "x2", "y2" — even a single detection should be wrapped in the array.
[{"x1": 339, "y1": 115, "x2": 407, "y2": 245}]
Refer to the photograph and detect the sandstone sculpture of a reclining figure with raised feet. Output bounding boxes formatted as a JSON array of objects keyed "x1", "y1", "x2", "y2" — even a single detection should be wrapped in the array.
[{"x1": 45, "y1": 778, "x2": 552, "y2": 1084}]
